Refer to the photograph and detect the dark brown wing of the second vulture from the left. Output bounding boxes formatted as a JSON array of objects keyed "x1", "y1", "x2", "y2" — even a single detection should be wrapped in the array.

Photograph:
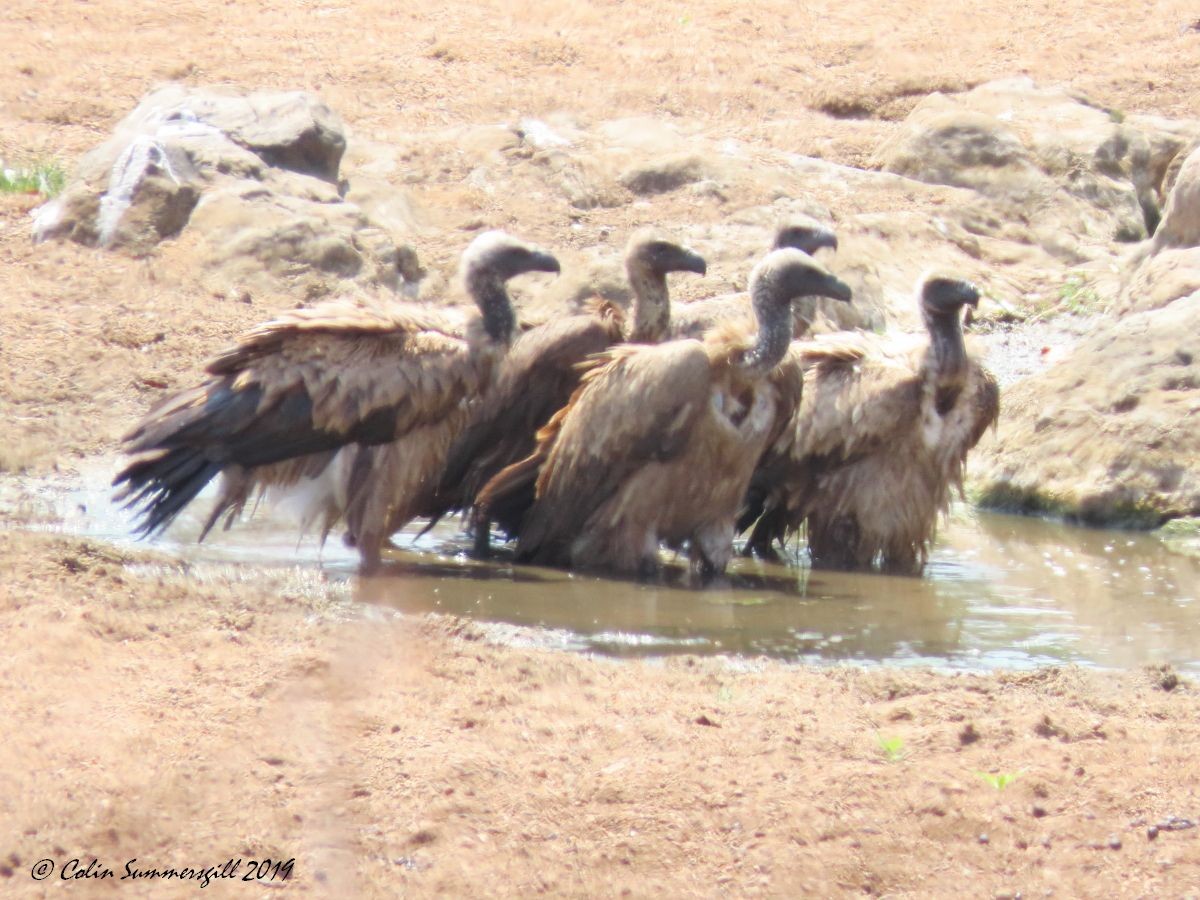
[{"x1": 436, "y1": 304, "x2": 622, "y2": 524}]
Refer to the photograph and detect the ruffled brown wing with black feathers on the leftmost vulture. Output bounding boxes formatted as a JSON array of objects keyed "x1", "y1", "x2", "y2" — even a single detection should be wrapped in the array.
[{"x1": 114, "y1": 301, "x2": 490, "y2": 534}]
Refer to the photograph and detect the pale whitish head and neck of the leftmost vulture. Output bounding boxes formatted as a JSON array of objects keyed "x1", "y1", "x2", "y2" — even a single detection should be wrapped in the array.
[{"x1": 460, "y1": 232, "x2": 560, "y2": 343}]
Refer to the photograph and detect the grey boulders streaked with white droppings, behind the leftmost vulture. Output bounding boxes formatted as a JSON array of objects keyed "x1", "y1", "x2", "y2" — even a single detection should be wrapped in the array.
[{"x1": 34, "y1": 84, "x2": 420, "y2": 294}]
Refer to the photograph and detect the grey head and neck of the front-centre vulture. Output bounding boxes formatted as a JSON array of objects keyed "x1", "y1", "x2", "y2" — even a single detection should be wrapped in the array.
[{"x1": 743, "y1": 247, "x2": 851, "y2": 373}]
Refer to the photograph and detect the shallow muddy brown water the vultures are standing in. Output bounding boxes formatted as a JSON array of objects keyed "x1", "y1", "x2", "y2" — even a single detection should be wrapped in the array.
[{"x1": 9, "y1": 463, "x2": 1200, "y2": 672}]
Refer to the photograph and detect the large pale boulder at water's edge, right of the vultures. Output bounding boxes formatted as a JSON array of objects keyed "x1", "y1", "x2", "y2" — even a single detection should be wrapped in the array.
[{"x1": 971, "y1": 293, "x2": 1200, "y2": 528}]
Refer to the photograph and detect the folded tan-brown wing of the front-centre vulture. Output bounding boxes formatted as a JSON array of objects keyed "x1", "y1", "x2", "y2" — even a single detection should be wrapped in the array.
[{"x1": 480, "y1": 341, "x2": 712, "y2": 559}]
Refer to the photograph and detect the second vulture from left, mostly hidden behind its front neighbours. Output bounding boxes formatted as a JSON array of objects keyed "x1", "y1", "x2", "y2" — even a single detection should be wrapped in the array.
[{"x1": 424, "y1": 228, "x2": 707, "y2": 556}]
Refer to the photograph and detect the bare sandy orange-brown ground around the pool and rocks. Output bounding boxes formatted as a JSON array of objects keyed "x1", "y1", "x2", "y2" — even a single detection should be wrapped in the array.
[{"x1": 0, "y1": 0, "x2": 1200, "y2": 898}]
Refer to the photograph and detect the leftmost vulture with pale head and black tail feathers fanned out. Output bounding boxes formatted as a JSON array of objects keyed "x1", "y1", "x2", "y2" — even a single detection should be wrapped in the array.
[{"x1": 114, "y1": 232, "x2": 559, "y2": 571}]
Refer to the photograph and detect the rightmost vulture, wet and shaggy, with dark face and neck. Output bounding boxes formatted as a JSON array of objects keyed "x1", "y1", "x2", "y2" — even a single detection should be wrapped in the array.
[{"x1": 738, "y1": 275, "x2": 1000, "y2": 575}]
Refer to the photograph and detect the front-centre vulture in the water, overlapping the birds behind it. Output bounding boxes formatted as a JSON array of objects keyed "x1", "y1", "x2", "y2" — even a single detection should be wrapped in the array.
[{"x1": 479, "y1": 248, "x2": 850, "y2": 578}]
